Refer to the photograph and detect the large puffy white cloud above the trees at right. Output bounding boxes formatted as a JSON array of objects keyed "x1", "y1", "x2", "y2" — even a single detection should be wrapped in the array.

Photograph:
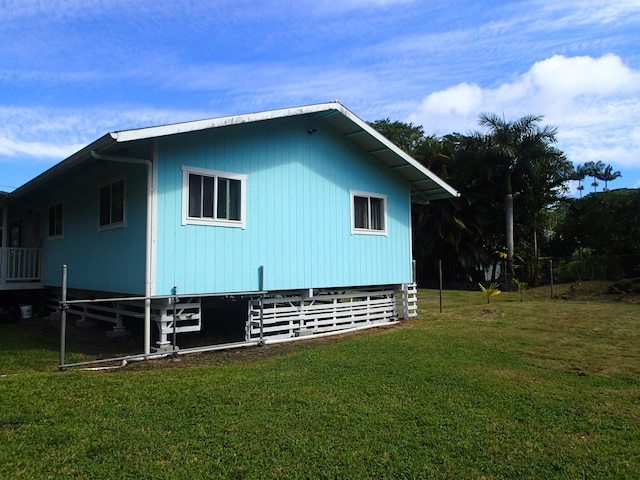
[{"x1": 408, "y1": 54, "x2": 640, "y2": 167}]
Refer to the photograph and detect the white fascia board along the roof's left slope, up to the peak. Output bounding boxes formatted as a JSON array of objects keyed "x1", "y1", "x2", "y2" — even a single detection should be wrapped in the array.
[{"x1": 111, "y1": 102, "x2": 346, "y2": 142}]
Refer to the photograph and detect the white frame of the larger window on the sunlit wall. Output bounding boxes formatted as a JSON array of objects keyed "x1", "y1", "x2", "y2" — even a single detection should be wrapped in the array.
[{"x1": 182, "y1": 166, "x2": 247, "y2": 229}]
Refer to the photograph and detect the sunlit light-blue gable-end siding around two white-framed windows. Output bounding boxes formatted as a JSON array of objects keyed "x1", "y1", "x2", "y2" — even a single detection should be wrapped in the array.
[{"x1": 158, "y1": 117, "x2": 411, "y2": 295}]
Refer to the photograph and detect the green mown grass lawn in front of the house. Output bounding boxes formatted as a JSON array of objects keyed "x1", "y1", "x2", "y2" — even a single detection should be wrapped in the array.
[{"x1": 0, "y1": 284, "x2": 640, "y2": 479}]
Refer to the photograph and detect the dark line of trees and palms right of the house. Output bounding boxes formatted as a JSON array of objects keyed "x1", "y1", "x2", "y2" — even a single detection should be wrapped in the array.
[{"x1": 370, "y1": 113, "x2": 640, "y2": 285}]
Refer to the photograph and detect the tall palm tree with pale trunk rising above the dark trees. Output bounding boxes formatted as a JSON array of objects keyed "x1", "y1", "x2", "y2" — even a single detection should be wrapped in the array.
[{"x1": 478, "y1": 113, "x2": 557, "y2": 277}]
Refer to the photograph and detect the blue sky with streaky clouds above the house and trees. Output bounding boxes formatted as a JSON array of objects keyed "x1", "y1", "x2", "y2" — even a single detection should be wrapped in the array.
[{"x1": 0, "y1": 0, "x2": 640, "y2": 191}]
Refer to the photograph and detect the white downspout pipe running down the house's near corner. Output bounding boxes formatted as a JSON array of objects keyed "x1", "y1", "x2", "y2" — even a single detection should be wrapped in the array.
[{"x1": 91, "y1": 150, "x2": 153, "y2": 355}]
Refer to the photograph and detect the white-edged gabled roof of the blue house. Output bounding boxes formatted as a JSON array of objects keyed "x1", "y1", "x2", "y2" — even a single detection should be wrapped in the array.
[{"x1": 11, "y1": 101, "x2": 459, "y2": 203}]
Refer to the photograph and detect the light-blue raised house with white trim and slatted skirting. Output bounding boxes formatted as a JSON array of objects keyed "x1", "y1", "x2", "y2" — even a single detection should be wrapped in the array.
[{"x1": 0, "y1": 102, "x2": 457, "y2": 353}]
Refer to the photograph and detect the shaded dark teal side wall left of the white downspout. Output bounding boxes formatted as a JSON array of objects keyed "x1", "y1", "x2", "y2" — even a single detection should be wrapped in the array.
[{"x1": 40, "y1": 162, "x2": 146, "y2": 294}]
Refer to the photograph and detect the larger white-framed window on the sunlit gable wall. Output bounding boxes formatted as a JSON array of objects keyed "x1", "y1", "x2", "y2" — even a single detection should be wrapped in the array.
[{"x1": 182, "y1": 167, "x2": 247, "y2": 228}]
